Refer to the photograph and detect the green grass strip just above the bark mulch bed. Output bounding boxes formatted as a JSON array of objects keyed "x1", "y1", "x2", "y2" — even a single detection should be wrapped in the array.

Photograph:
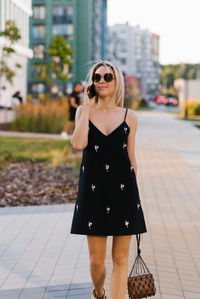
[{"x1": 0, "y1": 136, "x2": 80, "y2": 175}]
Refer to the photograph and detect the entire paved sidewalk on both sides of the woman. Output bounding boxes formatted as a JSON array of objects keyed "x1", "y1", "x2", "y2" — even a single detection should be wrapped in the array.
[{"x1": 0, "y1": 112, "x2": 200, "y2": 299}]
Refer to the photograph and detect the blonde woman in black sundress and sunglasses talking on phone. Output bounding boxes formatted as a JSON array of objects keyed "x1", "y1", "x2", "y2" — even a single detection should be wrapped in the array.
[{"x1": 71, "y1": 62, "x2": 147, "y2": 299}]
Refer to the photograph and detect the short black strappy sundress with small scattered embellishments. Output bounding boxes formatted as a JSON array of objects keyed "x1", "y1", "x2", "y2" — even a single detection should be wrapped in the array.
[{"x1": 70, "y1": 108, "x2": 147, "y2": 236}]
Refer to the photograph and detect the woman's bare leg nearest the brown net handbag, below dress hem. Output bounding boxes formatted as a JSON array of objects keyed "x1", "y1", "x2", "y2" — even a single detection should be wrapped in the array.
[{"x1": 110, "y1": 235, "x2": 132, "y2": 299}]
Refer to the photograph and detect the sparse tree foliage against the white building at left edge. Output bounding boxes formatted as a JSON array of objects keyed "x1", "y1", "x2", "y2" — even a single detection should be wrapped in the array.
[{"x1": 0, "y1": 20, "x2": 21, "y2": 85}]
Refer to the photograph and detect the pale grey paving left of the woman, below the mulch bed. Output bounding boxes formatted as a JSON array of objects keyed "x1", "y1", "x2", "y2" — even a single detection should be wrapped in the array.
[{"x1": 0, "y1": 204, "x2": 92, "y2": 299}]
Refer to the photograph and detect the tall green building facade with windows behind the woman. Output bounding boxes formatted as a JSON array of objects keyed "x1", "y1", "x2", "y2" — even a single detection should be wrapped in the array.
[{"x1": 28, "y1": 0, "x2": 107, "y2": 93}]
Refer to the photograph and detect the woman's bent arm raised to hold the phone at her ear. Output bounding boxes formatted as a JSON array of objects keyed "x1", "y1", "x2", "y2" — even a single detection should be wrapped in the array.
[{"x1": 71, "y1": 86, "x2": 95, "y2": 151}]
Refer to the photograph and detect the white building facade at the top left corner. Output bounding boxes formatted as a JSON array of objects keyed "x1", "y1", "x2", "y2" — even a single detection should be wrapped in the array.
[{"x1": 0, "y1": 0, "x2": 33, "y2": 100}]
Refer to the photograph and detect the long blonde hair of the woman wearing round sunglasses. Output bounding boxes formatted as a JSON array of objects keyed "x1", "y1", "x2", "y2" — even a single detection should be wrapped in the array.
[{"x1": 88, "y1": 61, "x2": 124, "y2": 107}]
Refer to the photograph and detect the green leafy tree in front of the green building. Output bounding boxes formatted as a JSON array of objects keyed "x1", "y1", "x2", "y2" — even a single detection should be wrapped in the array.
[{"x1": 34, "y1": 35, "x2": 73, "y2": 97}]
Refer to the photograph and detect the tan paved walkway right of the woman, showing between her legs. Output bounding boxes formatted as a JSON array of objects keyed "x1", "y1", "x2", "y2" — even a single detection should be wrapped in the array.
[{"x1": 101, "y1": 112, "x2": 200, "y2": 299}]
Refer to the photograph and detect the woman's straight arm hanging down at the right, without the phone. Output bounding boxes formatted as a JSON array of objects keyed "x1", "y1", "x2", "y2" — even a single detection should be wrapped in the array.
[{"x1": 127, "y1": 109, "x2": 138, "y2": 176}]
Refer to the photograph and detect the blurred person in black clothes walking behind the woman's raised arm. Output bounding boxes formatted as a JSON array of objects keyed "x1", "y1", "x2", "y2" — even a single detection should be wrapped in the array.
[{"x1": 61, "y1": 82, "x2": 84, "y2": 139}]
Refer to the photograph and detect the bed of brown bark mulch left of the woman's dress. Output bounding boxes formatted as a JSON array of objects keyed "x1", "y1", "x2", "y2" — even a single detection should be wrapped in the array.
[{"x1": 0, "y1": 162, "x2": 78, "y2": 207}]
